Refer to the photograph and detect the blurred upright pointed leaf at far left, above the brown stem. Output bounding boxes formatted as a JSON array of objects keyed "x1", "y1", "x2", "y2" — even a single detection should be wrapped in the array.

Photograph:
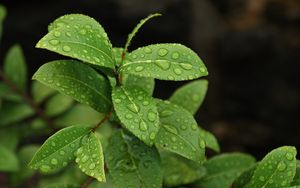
[{"x1": 3, "y1": 45, "x2": 27, "y2": 91}]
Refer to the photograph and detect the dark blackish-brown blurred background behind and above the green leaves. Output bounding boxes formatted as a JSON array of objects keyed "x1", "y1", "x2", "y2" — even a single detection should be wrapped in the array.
[{"x1": 0, "y1": 0, "x2": 300, "y2": 158}]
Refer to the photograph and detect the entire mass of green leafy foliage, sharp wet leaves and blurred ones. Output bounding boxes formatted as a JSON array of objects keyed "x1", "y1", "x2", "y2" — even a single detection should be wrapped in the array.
[{"x1": 0, "y1": 6, "x2": 300, "y2": 188}]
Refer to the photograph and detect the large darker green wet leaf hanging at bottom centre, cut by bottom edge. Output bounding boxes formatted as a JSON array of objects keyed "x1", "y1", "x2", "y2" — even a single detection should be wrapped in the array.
[{"x1": 106, "y1": 131, "x2": 162, "y2": 188}]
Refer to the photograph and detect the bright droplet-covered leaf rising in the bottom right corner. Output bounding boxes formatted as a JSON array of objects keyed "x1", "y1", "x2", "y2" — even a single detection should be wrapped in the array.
[{"x1": 245, "y1": 146, "x2": 297, "y2": 188}]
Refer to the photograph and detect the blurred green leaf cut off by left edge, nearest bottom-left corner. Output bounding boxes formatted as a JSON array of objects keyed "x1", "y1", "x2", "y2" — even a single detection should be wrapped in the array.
[{"x1": 0, "y1": 146, "x2": 19, "y2": 172}]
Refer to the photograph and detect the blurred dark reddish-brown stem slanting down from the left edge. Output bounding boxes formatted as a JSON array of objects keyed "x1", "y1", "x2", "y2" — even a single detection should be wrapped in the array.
[{"x1": 0, "y1": 69, "x2": 56, "y2": 130}]
